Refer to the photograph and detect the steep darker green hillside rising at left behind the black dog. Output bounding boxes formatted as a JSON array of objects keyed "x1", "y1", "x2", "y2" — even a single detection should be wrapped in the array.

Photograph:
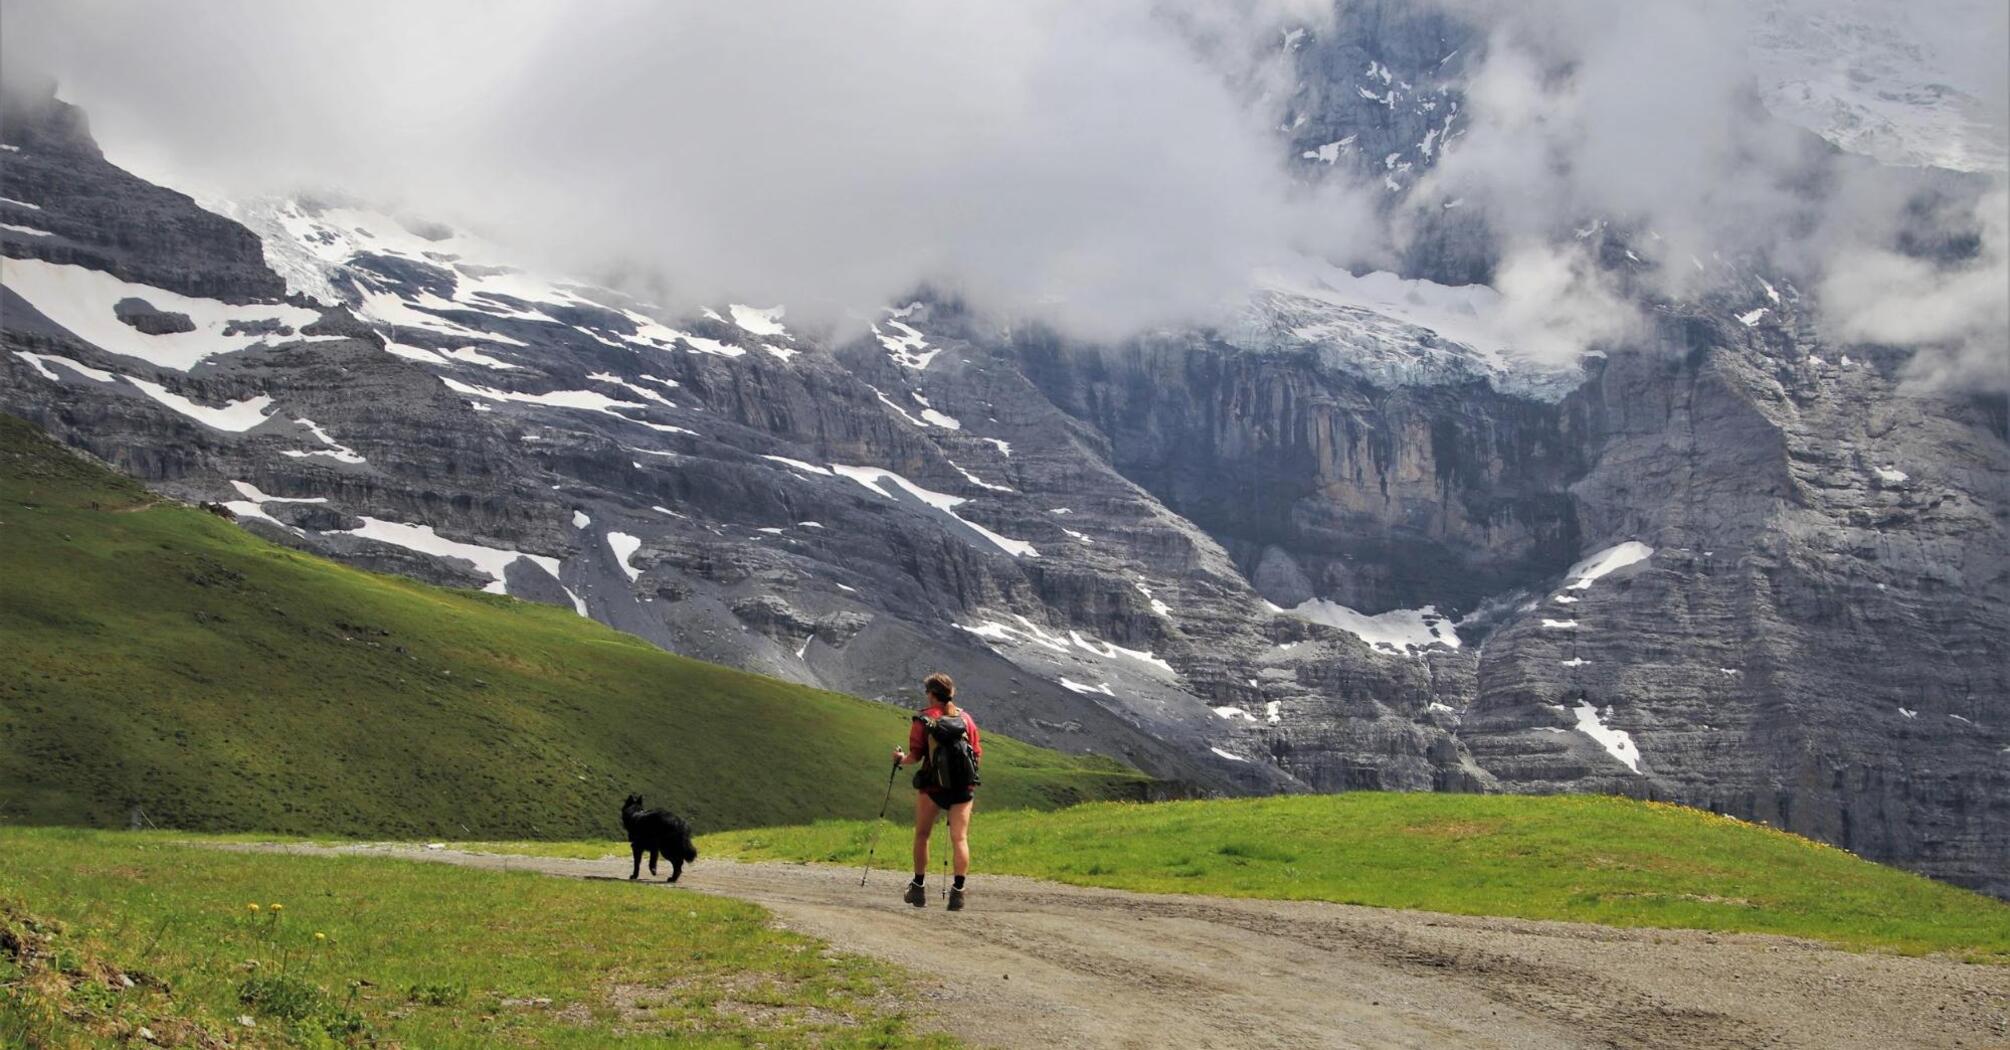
[{"x1": 0, "y1": 416, "x2": 1140, "y2": 839}]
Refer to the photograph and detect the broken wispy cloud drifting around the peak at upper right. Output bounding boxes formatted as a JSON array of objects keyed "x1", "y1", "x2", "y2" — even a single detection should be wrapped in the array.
[{"x1": 1413, "y1": 0, "x2": 2010, "y2": 388}]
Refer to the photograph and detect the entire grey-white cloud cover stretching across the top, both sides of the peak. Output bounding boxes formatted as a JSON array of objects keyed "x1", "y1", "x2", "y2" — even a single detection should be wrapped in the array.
[{"x1": 0, "y1": 0, "x2": 2010, "y2": 384}]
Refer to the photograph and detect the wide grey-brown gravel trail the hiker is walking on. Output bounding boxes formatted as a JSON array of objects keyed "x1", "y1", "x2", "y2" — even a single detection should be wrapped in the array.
[{"x1": 239, "y1": 847, "x2": 2010, "y2": 1050}]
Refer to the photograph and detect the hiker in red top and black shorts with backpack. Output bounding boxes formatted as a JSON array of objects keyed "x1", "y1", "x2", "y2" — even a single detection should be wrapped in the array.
[{"x1": 892, "y1": 674, "x2": 985, "y2": 911}]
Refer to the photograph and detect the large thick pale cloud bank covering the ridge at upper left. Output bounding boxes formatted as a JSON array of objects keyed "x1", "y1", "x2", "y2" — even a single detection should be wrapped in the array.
[{"x1": 6, "y1": 0, "x2": 1371, "y2": 336}]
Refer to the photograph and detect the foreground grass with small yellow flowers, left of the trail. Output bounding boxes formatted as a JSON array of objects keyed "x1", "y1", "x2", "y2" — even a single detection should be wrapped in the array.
[{"x1": 0, "y1": 829, "x2": 947, "y2": 1048}]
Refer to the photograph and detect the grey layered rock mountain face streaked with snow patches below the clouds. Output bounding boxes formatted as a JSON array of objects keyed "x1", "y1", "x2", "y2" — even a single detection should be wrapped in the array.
[{"x1": 0, "y1": 4, "x2": 2010, "y2": 893}]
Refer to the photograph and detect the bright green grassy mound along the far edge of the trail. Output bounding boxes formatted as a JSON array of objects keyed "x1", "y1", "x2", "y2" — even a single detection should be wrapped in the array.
[{"x1": 699, "y1": 793, "x2": 2010, "y2": 964}]
